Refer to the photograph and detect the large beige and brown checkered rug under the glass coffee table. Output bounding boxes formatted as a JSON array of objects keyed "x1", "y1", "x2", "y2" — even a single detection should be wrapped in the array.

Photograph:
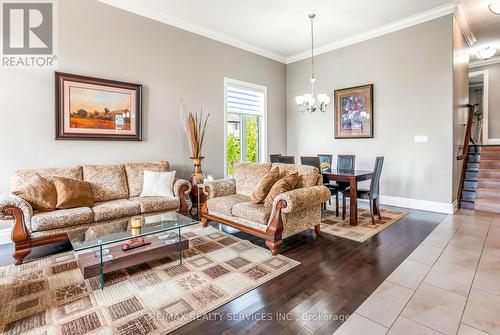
[{"x1": 0, "y1": 226, "x2": 299, "y2": 335}]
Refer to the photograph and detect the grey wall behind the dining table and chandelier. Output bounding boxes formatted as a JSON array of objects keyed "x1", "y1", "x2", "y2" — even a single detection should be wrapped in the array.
[{"x1": 287, "y1": 15, "x2": 453, "y2": 203}]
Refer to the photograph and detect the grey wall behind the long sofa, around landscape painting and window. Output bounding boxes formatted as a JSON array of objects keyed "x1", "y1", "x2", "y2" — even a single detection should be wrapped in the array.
[{"x1": 0, "y1": 0, "x2": 286, "y2": 193}]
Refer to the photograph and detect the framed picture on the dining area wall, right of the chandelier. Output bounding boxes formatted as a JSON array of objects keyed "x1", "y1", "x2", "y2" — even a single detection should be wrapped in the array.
[{"x1": 334, "y1": 84, "x2": 373, "y2": 138}]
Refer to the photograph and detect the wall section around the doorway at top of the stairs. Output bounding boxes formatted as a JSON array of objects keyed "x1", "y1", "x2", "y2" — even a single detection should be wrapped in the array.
[{"x1": 470, "y1": 63, "x2": 500, "y2": 139}]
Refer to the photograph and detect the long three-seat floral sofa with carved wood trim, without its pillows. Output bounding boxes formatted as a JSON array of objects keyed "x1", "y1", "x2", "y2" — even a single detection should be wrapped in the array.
[{"x1": 0, "y1": 161, "x2": 191, "y2": 264}]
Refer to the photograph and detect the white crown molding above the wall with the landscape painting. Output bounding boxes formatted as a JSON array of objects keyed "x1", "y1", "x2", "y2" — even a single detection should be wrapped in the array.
[{"x1": 99, "y1": 0, "x2": 286, "y2": 63}]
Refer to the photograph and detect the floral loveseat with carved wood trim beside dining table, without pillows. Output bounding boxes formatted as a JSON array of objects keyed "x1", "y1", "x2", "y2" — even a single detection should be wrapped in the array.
[{"x1": 202, "y1": 163, "x2": 330, "y2": 255}]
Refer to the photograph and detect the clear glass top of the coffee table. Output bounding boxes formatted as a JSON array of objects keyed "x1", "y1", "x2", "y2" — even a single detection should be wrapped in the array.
[{"x1": 68, "y1": 212, "x2": 199, "y2": 251}]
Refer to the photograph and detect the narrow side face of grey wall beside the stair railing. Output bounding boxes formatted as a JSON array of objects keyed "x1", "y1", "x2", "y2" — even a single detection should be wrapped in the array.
[{"x1": 451, "y1": 18, "x2": 469, "y2": 200}]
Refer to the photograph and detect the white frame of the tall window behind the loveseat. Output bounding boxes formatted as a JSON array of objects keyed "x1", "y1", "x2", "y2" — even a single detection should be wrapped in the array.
[{"x1": 223, "y1": 77, "x2": 268, "y2": 178}]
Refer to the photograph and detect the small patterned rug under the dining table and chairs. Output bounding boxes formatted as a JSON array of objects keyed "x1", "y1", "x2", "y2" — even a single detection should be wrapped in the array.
[{"x1": 321, "y1": 207, "x2": 408, "y2": 242}]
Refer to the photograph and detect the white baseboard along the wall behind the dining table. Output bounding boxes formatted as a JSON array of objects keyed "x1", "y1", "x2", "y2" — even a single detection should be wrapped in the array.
[{"x1": 327, "y1": 195, "x2": 457, "y2": 214}]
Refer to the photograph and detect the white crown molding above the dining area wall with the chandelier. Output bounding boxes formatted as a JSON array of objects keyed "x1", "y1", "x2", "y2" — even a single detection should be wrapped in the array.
[{"x1": 286, "y1": 1, "x2": 457, "y2": 64}]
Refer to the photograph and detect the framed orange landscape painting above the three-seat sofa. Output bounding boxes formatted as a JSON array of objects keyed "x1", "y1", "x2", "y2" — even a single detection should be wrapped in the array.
[{"x1": 56, "y1": 72, "x2": 142, "y2": 141}]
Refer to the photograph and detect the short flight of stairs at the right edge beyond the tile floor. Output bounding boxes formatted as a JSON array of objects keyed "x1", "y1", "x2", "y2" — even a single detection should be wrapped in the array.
[{"x1": 460, "y1": 145, "x2": 500, "y2": 213}]
